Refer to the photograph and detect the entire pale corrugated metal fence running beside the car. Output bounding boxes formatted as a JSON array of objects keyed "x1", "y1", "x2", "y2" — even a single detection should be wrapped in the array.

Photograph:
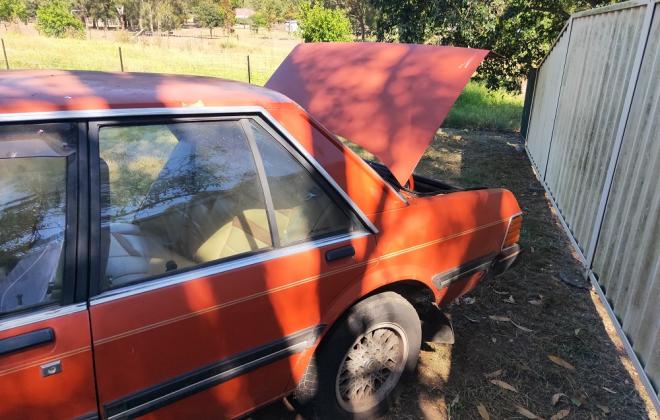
[{"x1": 526, "y1": 0, "x2": 660, "y2": 409}]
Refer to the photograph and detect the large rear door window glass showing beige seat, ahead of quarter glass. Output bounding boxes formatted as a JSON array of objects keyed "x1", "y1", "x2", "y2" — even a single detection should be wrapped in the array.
[{"x1": 99, "y1": 121, "x2": 272, "y2": 289}]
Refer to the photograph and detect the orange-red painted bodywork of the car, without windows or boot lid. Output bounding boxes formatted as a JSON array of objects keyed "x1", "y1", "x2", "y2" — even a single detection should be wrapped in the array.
[{"x1": 0, "y1": 67, "x2": 520, "y2": 418}]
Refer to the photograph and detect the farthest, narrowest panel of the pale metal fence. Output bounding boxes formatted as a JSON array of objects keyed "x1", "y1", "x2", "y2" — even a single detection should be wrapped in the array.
[{"x1": 527, "y1": 28, "x2": 569, "y2": 176}]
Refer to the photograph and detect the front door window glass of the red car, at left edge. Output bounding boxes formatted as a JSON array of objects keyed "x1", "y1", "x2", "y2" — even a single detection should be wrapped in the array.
[{"x1": 0, "y1": 124, "x2": 78, "y2": 316}]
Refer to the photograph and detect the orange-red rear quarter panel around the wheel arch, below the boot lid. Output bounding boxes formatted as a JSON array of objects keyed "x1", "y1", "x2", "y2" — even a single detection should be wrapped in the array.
[{"x1": 290, "y1": 189, "x2": 520, "y2": 386}]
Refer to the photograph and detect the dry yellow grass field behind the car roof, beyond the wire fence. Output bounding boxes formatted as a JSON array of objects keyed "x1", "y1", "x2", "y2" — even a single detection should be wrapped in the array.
[{"x1": 0, "y1": 25, "x2": 298, "y2": 85}]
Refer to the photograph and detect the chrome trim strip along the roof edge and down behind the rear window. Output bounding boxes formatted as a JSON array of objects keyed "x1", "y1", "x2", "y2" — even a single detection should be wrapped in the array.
[{"x1": 0, "y1": 106, "x2": 378, "y2": 233}]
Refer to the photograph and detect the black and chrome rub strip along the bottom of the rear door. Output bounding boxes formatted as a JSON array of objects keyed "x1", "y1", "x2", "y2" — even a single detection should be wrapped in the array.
[{"x1": 103, "y1": 325, "x2": 325, "y2": 420}]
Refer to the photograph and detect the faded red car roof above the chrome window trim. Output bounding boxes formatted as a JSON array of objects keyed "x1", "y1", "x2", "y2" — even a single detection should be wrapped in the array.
[{"x1": 0, "y1": 70, "x2": 292, "y2": 114}]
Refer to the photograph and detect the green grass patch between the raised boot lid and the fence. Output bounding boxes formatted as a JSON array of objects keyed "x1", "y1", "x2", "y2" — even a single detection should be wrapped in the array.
[{"x1": 443, "y1": 82, "x2": 523, "y2": 131}]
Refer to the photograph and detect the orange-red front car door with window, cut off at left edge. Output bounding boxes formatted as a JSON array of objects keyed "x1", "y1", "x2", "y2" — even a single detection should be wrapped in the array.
[{"x1": 0, "y1": 123, "x2": 97, "y2": 419}]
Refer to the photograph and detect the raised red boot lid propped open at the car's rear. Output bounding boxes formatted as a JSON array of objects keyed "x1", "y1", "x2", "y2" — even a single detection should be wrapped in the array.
[{"x1": 266, "y1": 42, "x2": 488, "y2": 185}]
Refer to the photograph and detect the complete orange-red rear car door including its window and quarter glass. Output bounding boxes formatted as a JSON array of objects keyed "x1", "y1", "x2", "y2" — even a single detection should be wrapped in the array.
[{"x1": 90, "y1": 115, "x2": 372, "y2": 418}]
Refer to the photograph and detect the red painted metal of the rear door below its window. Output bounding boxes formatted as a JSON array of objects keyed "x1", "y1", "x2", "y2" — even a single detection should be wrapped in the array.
[{"x1": 90, "y1": 235, "x2": 373, "y2": 417}]
